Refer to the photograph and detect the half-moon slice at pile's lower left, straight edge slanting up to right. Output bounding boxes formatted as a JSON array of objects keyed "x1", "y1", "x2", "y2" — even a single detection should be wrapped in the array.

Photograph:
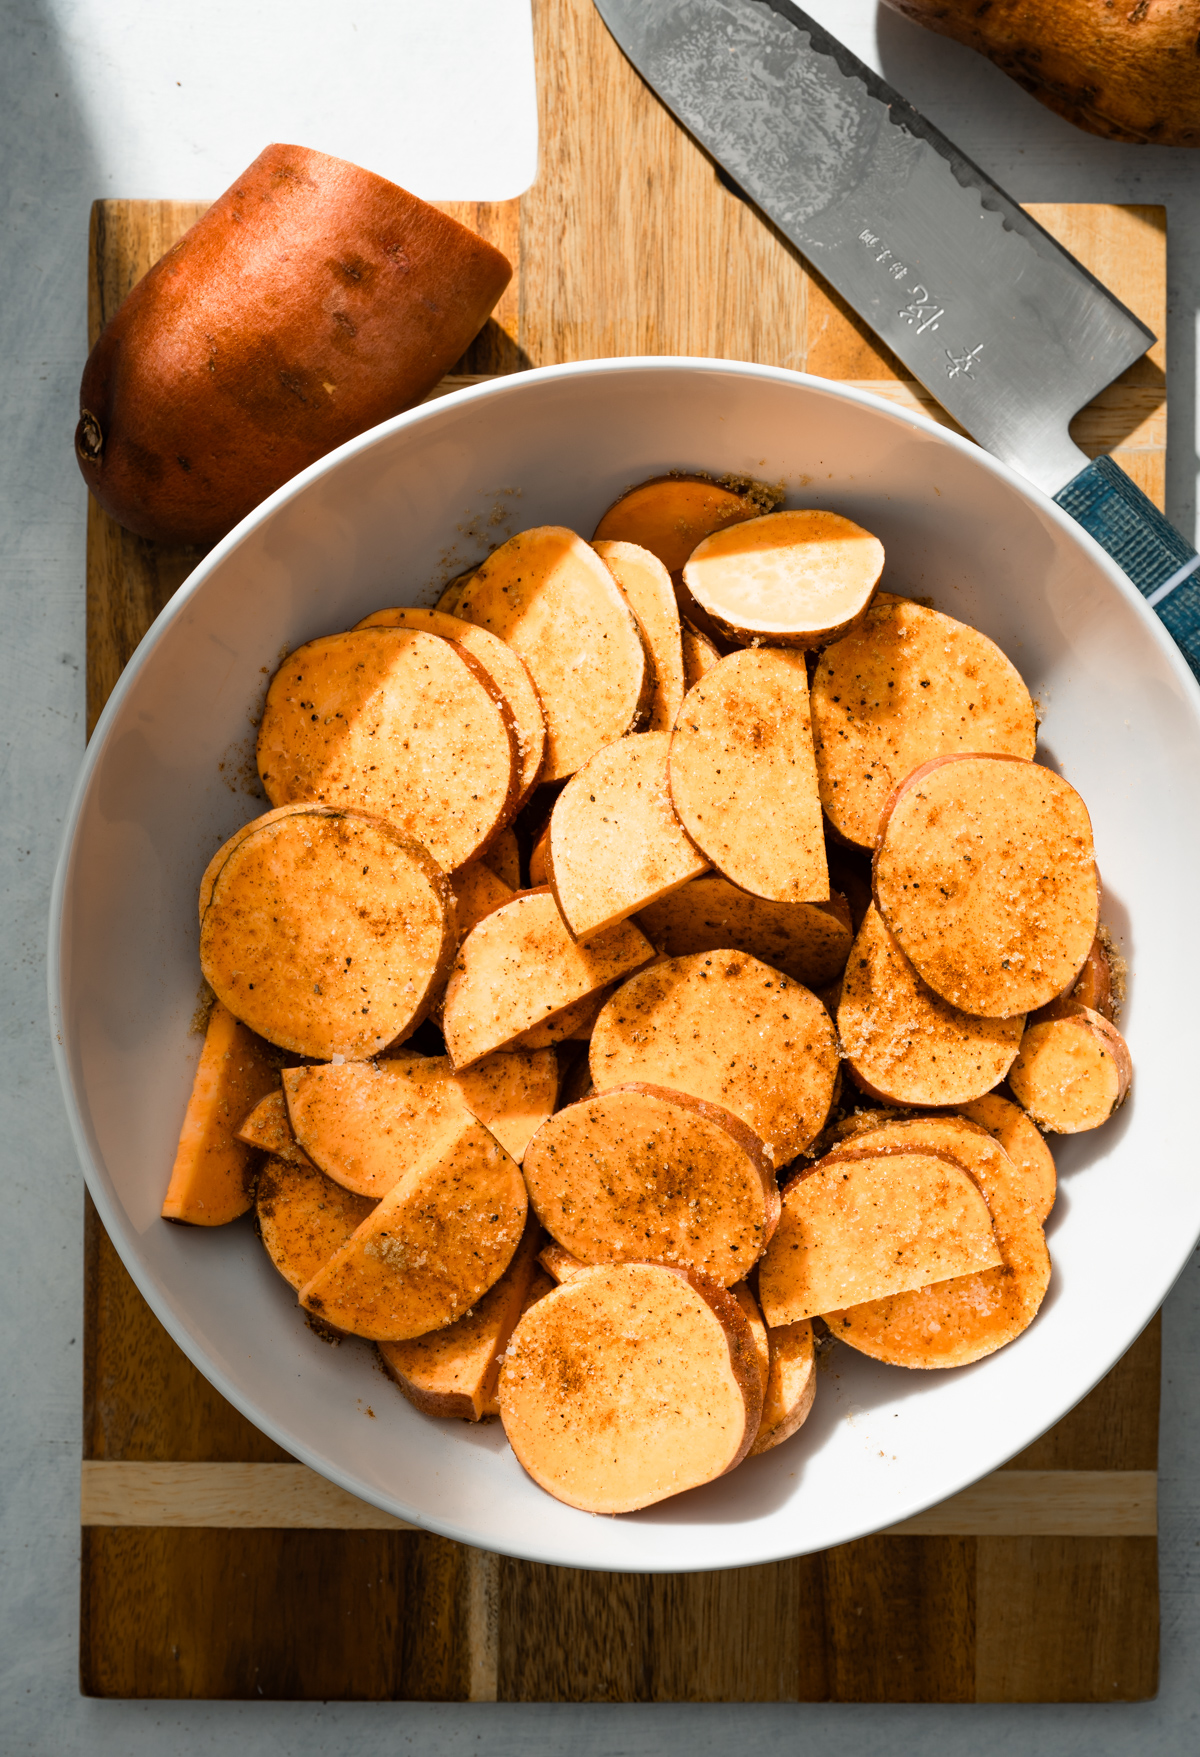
[{"x1": 300, "y1": 1110, "x2": 529, "y2": 1342}]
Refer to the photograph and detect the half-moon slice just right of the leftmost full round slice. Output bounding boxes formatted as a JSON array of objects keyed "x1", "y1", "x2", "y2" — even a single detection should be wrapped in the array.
[{"x1": 443, "y1": 889, "x2": 654, "y2": 1068}]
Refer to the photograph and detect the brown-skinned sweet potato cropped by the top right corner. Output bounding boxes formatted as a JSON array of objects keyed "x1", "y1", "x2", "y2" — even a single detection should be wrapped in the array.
[{"x1": 887, "y1": 0, "x2": 1200, "y2": 146}]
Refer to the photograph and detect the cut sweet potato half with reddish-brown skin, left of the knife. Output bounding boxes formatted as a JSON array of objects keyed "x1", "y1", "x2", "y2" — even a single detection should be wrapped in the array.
[{"x1": 76, "y1": 146, "x2": 511, "y2": 545}]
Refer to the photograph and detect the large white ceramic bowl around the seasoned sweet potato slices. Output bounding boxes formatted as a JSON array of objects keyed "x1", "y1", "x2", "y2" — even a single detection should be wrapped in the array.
[{"x1": 51, "y1": 358, "x2": 1200, "y2": 1571}]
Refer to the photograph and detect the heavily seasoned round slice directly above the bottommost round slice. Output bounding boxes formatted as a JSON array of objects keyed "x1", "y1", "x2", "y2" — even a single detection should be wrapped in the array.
[{"x1": 524, "y1": 1084, "x2": 778, "y2": 1286}]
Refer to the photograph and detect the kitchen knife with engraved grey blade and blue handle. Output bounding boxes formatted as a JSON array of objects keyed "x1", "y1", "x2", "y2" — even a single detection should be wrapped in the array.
[{"x1": 596, "y1": 0, "x2": 1200, "y2": 678}]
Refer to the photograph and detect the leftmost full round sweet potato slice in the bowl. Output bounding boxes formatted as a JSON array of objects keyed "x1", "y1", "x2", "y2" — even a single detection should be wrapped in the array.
[{"x1": 200, "y1": 806, "x2": 457, "y2": 1061}]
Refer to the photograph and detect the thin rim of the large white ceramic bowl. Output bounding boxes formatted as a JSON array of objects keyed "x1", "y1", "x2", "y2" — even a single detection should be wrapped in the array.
[{"x1": 46, "y1": 355, "x2": 1200, "y2": 1573}]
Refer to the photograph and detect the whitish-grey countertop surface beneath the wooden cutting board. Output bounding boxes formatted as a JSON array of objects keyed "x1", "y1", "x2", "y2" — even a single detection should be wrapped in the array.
[{"x1": 0, "y1": 0, "x2": 1200, "y2": 1757}]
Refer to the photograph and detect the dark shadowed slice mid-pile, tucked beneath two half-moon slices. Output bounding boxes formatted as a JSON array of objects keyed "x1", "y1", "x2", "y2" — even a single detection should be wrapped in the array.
[{"x1": 638, "y1": 873, "x2": 854, "y2": 987}]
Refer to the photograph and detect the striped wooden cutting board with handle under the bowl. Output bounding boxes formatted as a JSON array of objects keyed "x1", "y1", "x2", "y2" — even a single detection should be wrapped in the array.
[{"x1": 81, "y1": 0, "x2": 1167, "y2": 1703}]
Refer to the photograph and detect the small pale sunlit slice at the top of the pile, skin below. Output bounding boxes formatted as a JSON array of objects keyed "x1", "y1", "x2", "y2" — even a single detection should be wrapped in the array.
[{"x1": 683, "y1": 508, "x2": 884, "y2": 647}]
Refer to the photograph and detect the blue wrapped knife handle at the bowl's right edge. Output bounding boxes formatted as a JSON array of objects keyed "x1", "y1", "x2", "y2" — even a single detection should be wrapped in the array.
[{"x1": 1054, "y1": 457, "x2": 1200, "y2": 682}]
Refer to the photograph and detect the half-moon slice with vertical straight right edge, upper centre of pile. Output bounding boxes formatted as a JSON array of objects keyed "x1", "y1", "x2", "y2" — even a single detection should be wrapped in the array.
[{"x1": 669, "y1": 647, "x2": 829, "y2": 903}]
